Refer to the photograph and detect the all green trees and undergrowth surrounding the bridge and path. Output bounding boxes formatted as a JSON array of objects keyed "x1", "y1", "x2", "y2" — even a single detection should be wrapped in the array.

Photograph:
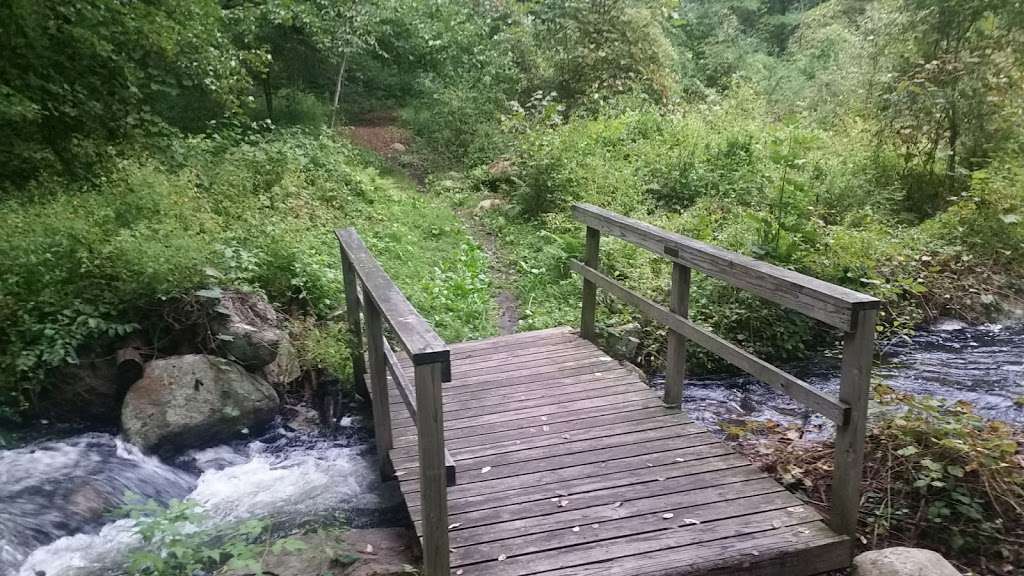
[{"x1": 0, "y1": 0, "x2": 1024, "y2": 563}]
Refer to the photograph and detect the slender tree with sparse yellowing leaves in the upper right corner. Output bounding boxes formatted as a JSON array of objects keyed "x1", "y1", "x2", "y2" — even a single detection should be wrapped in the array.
[{"x1": 880, "y1": 0, "x2": 1024, "y2": 212}]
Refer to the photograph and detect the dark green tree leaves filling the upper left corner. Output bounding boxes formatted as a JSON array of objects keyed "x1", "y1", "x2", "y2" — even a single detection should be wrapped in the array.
[{"x1": 0, "y1": 0, "x2": 249, "y2": 183}]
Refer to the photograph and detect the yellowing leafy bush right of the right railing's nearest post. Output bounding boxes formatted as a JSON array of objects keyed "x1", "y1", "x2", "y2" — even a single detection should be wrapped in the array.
[{"x1": 866, "y1": 388, "x2": 1024, "y2": 563}]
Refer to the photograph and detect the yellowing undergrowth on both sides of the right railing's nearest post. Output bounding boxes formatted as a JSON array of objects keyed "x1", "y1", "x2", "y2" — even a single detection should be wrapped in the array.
[{"x1": 740, "y1": 385, "x2": 1024, "y2": 575}]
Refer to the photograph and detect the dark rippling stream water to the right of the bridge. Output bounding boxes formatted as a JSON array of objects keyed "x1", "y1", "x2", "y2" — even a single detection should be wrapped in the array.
[{"x1": 653, "y1": 321, "x2": 1024, "y2": 438}]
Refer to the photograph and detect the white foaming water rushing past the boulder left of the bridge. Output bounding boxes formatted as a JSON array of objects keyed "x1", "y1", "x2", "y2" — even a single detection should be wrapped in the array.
[{"x1": 0, "y1": 417, "x2": 404, "y2": 576}]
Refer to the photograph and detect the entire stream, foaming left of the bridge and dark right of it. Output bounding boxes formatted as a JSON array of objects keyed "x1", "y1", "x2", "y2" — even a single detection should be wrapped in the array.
[{"x1": 0, "y1": 321, "x2": 1024, "y2": 576}]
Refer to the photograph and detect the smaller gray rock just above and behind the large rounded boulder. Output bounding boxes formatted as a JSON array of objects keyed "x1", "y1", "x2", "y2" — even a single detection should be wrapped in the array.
[{"x1": 211, "y1": 290, "x2": 287, "y2": 370}]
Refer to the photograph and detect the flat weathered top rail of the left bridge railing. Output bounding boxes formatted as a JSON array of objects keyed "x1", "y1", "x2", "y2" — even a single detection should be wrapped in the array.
[{"x1": 335, "y1": 228, "x2": 450, "y2": 368}]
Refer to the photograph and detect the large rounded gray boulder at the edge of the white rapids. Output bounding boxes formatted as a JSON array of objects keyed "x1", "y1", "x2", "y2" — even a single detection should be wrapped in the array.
[{"x1": 121, "y1": 354, "x2": 280, "y2": 454}]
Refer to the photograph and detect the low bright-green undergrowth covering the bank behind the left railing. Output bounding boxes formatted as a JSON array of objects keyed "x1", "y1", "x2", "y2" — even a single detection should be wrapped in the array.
[{"x1": 0, "y1": 132, "x2": 494, "y2": 411}]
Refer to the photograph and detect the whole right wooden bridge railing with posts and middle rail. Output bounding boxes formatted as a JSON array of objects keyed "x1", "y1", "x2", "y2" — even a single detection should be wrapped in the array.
[{"x1": 571, "y1": 204, "x2": 881, "y2": 537}]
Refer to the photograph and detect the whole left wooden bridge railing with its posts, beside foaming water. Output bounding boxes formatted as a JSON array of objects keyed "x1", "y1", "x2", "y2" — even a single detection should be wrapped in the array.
[{"x1": 336, "y1": 229, "x2": 456, "y2": 576}]
